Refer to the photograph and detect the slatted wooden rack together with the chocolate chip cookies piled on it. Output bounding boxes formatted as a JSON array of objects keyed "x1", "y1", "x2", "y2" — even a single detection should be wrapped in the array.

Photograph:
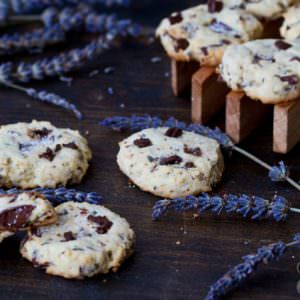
[{"x1": 157, "y1": 0, "x2": 300, "y2": 153}]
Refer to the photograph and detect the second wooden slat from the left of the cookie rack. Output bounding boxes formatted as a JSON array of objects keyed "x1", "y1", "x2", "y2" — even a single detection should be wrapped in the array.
[{"x1": 192, "y1": 67, "x2": 229, "y2": 124}]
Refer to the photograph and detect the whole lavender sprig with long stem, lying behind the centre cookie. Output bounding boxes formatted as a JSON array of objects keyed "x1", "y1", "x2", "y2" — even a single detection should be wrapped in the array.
[{"x1": 100, "y1": 115, "x2": 300, "y2": 191}]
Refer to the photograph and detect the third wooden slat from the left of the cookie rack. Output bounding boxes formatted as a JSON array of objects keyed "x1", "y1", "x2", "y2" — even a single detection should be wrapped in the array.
[{"x1": 226, "y1": 91, "x2": 272, "y2": 143}]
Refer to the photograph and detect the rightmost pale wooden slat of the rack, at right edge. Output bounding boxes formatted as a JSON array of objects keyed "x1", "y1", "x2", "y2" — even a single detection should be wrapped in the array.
[{"x1": 273, "y1": 99, "x2": 300, "y2": 154}]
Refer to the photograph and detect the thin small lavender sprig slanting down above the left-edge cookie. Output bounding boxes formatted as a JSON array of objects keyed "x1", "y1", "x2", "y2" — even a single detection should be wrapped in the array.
[{"x1": 0, "y1": 79, "x2": 83, "y2": 120}]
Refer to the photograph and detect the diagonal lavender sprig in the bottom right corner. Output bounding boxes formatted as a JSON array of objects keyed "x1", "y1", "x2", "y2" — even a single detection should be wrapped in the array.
[{"x1": 205, "y1": 233, "x2": 300, "y2": 300}]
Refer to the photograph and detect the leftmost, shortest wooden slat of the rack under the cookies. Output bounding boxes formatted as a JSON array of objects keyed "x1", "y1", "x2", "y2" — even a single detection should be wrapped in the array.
[{"x1": 171, "y1": 59, "x2": 199, "y2": 96}]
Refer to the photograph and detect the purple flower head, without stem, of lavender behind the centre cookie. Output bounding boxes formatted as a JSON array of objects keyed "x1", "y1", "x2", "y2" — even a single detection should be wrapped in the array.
[{"x1": 100, "y1": 115, "x2": 233, "y2": 148}]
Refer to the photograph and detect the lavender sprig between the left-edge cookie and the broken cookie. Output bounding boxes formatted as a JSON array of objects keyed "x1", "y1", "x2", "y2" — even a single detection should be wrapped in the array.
[{"x1": 0, "y1": 187, "x2": 103, "y2": 205}]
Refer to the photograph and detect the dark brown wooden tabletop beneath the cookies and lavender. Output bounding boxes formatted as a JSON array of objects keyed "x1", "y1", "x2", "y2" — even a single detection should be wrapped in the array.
[{"x1": 0, "y1": 0, "x2": 300, "y2": 300}]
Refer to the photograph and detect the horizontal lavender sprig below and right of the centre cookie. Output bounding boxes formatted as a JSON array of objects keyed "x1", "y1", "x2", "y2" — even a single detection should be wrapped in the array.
[{"x1": 152, "y1": 193, "x2": 300, "y2": 222}]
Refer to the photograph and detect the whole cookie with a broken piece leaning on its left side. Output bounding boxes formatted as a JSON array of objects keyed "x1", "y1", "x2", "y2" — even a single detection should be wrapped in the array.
[{"x1": 21, "y1": 202, "x2": 135, "y2": 279}]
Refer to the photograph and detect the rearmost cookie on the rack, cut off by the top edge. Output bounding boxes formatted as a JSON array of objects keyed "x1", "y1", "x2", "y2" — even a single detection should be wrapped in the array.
[{"x1": 220, "y1": 0, "x2": 294, "y2": 20}]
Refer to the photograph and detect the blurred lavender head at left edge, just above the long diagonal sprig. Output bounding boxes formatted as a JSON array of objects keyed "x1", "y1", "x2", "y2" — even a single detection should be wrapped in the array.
[{"x1": 0, "y1": 25, "x2": 65, "y2": 55}]
